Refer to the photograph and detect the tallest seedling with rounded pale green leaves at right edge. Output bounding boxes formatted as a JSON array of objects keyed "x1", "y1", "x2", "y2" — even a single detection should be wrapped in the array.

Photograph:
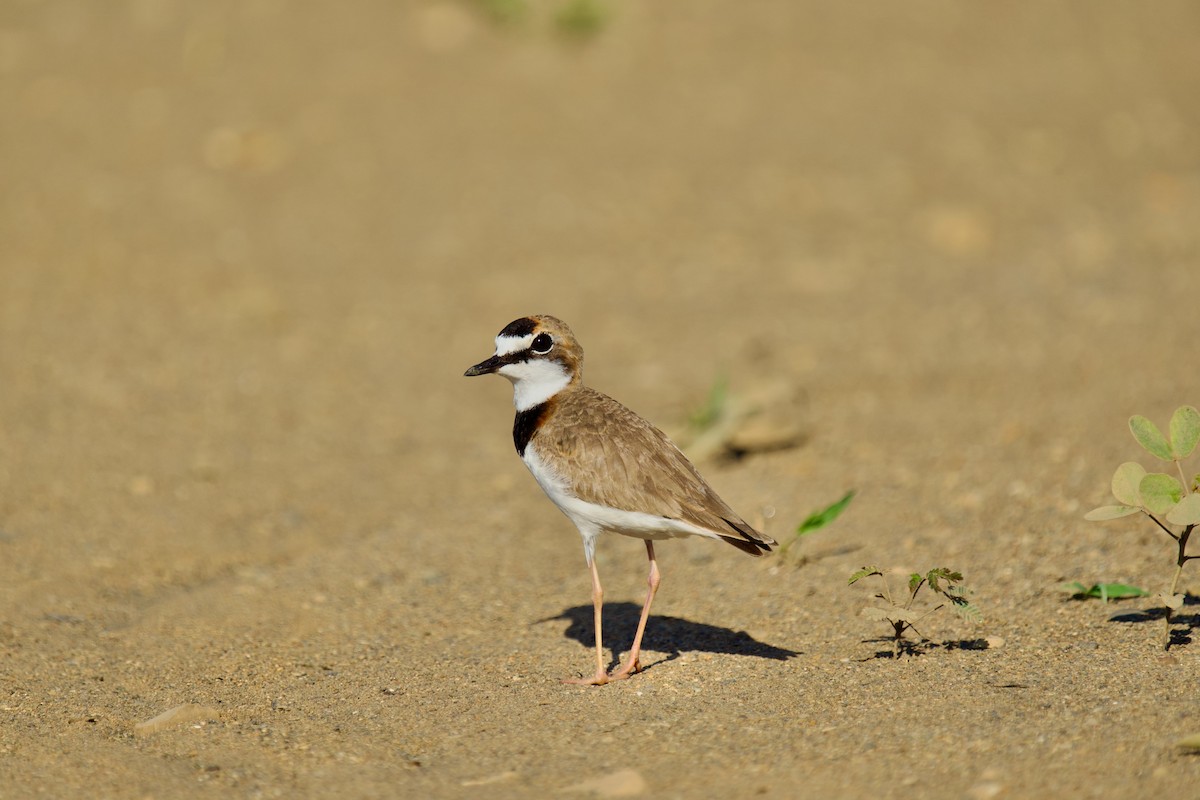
[{"x1": 1084, "y1": 405, "x2": 1200, "y2": 650}]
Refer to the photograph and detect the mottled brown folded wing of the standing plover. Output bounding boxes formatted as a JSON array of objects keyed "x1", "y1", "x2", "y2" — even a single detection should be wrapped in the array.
[{"x1": 534, "y1": 386, "x2": 775, "y2": 555}]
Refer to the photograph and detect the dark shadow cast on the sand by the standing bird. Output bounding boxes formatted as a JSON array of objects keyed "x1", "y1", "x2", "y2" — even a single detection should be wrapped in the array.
[{"x1": 538, "y1": 602, "x2": 800, "y2": 669}]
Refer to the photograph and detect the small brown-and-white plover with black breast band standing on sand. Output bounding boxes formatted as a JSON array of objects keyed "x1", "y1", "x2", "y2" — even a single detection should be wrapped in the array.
[{"x1": 464, "y1": 314, "x2": 776, "y2": 686}]
